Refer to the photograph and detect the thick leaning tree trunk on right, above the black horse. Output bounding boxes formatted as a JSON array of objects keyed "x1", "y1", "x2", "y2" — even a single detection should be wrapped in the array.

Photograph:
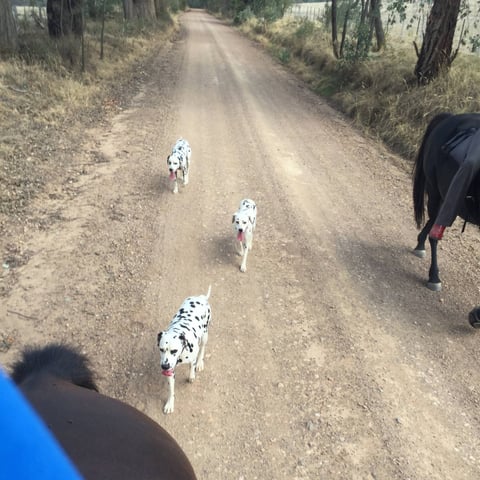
[{"x1": 415, "y1": 0, "x2": 461, "y2": 85}]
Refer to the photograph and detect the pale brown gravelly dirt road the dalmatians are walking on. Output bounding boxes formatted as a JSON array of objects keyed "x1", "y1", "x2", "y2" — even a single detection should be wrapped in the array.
[{"x1": 0, "y1": 11, "x2": 480, "y2": 480}]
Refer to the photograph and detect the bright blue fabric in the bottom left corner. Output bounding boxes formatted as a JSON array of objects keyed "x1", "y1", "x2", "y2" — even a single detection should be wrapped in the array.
[{"x1": 0, "y1": 368, "x2": 82, "y2": 480}]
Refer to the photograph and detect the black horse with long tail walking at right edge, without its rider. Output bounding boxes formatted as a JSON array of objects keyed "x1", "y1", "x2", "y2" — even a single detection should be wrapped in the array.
[{"x1": 413, "y1": 113, "x2": 480, "y2": 291}]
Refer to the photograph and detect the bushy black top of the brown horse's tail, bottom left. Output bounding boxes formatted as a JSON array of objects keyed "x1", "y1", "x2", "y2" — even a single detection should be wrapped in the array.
[{"x1": 10, "y1": 343, "x2": 98, "y2": 392}]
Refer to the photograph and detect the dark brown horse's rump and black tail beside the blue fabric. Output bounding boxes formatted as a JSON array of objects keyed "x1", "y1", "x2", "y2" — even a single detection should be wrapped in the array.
[{"x1": 11, "y1": 344, "x2": 196, "y2": 480}]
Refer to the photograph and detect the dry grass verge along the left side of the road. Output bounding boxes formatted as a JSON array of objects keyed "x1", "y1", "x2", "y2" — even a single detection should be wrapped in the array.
[{"x1": 0, "y1": 13, "x2": 177, "y2": 217}]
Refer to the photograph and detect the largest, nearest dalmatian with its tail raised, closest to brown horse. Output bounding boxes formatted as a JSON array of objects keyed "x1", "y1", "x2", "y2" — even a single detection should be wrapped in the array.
[{"x1": 157, "y1": 286, "x2": 211, "y2": 413}]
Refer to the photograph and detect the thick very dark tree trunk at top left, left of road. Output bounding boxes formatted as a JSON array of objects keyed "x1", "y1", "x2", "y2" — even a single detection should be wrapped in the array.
[{"x1": 47, "y1": 0, "x2": 83, "y2": 37}]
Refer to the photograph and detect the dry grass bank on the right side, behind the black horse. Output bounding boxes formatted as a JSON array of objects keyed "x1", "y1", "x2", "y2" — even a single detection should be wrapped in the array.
[{"x1": 241, "y1": 17, "x2": 480, "y2": 159}]
